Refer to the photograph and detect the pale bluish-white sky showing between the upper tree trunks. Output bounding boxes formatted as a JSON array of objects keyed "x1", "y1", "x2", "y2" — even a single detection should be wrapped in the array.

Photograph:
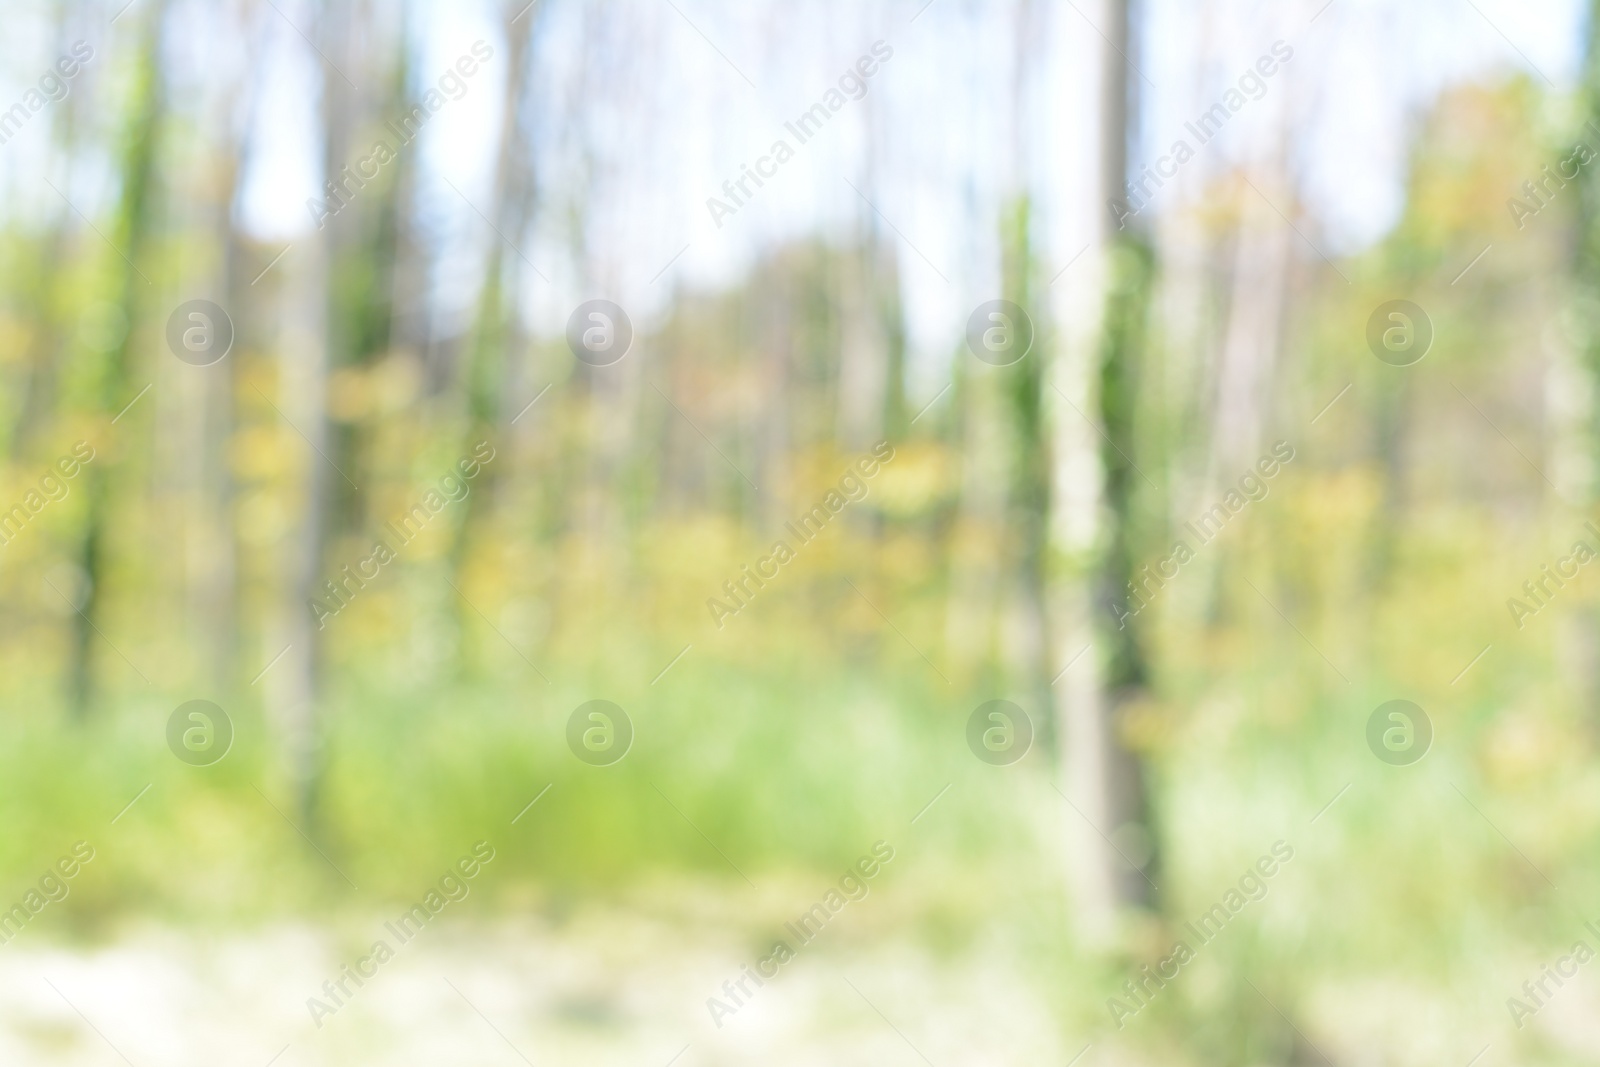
[{"x1": 0, "y1": 0, "x2": 1584, "y2": 398}]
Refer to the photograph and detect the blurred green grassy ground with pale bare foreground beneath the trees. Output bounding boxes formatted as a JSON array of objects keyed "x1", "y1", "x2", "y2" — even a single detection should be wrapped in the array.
[{"x1": 9, "y1": 464, "x2": 1600, "y2": 1064}]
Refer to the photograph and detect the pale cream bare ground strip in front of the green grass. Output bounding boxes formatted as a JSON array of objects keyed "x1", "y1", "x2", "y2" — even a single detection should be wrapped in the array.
[{"x1": 0, "y1": 894, "x2": 1083, "y2": 1067}]
